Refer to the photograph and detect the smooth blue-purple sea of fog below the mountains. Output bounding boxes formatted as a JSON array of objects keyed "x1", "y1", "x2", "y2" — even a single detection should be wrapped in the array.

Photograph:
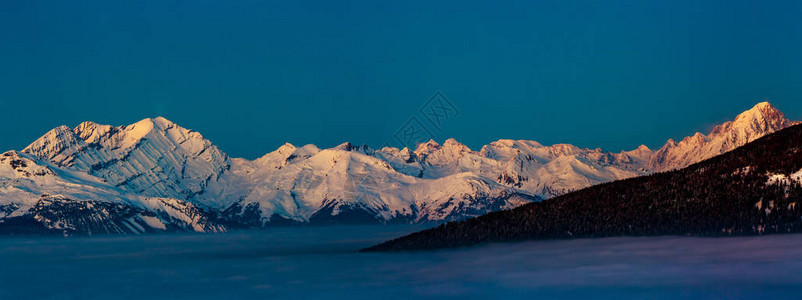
[{"x1": 0, "y1": 226, "x2": 802, "y2": 300}]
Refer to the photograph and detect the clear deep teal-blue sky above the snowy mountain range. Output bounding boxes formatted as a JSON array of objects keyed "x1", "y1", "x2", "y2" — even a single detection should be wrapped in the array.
[{"x1": 0, "y1": 0, "x2": 802, "y2": 158}]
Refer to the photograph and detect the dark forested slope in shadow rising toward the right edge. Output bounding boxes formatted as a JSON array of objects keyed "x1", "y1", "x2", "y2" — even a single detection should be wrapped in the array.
[{"x1": 366, "y1": 125, "x2": 802, "y2": 251}]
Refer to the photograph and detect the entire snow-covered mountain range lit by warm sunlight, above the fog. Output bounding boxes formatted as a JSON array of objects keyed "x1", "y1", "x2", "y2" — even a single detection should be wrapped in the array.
[{"x1": 0, "y1": 102, "x2": 795, "y2": 234}]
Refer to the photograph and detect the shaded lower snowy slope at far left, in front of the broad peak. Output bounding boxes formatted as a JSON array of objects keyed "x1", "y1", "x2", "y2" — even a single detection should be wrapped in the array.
[{"x1": 0, "y1": 151, "x2": 225, "y2": 235}]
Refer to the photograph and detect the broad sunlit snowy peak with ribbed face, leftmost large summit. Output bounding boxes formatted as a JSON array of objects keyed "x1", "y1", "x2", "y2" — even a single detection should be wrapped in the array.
[{"x1": 23, "y1": 117, "x2": 230, "y2": 204}]
